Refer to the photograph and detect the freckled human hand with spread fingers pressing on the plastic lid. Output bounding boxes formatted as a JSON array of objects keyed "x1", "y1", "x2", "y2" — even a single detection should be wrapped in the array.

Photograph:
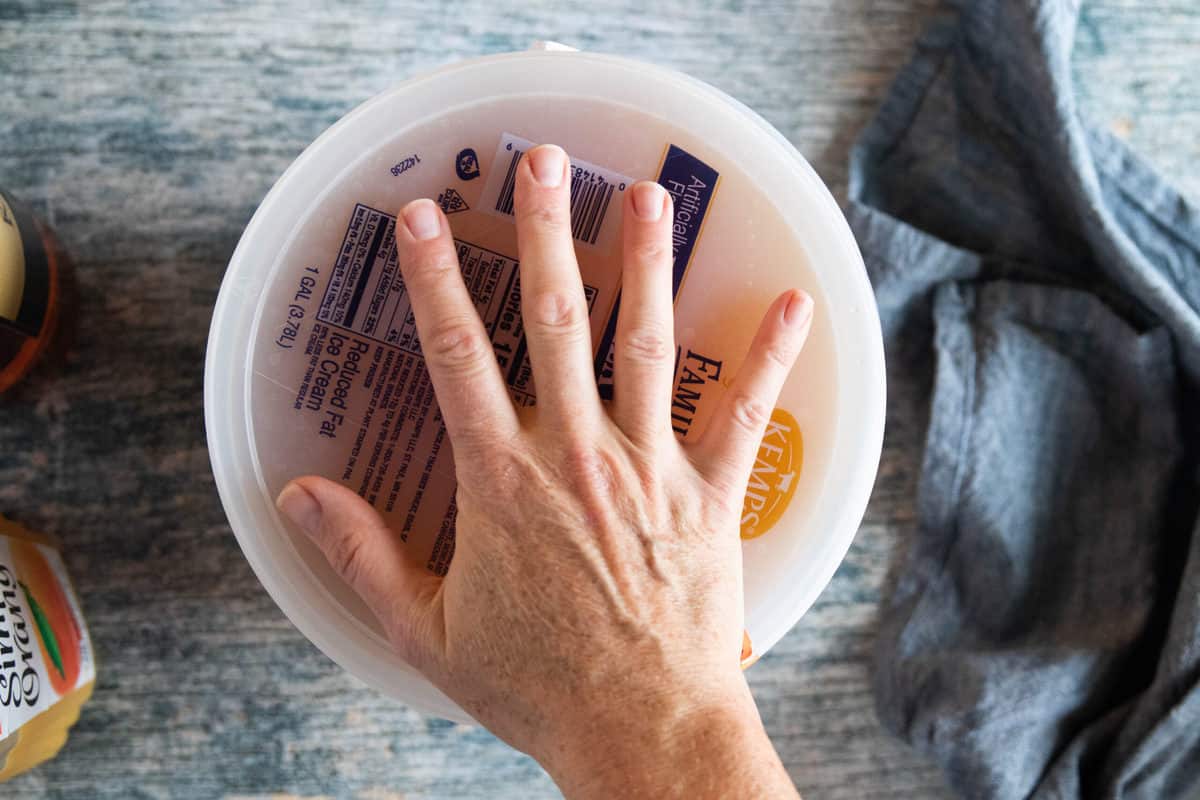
[{"x1": 278, "y1": 145, "x2": 812, "y2": 796}]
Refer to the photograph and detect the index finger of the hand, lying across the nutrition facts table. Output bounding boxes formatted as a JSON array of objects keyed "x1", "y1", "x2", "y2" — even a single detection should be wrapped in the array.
[{"x1": 396, "y1": 199, "x2": 518, "y2": 450}]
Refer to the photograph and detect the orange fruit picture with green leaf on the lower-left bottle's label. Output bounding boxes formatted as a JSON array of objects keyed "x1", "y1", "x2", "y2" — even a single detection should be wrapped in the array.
[{"x1": 10, "y1": 540, "x2": 83, "y2": 696}]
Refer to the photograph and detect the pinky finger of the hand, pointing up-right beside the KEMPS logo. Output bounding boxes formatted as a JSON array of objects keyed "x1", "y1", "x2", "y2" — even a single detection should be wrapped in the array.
[{"x1": 691, "y1": 289, "x2": 812, "y2": 498}]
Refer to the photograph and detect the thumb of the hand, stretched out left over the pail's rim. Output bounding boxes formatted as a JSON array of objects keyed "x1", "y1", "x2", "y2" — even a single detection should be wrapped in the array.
[{"x1": 275, "y1": 476, "x2": 442, "y2": 666}]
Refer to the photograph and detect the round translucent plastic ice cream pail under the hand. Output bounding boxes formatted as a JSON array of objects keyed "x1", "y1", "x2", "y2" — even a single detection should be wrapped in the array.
[{"x1": 204, "y1": 50, "x2": 884, "y2": 720}]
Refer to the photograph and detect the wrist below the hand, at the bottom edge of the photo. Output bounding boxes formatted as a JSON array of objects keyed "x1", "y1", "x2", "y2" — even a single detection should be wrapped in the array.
[{"x1": 534, "y1": 675, "x2": 794, "y2": 800}]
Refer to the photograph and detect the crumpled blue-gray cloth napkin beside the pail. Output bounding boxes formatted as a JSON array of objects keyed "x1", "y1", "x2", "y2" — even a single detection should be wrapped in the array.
[{"x1": 848, "y1": 0, "x2": 1200, "y2": 799}]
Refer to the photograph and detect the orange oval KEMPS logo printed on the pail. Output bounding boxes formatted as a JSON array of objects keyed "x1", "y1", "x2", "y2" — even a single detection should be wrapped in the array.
[{"x1": 742, "y1": 408, "x2": 804, "y2": 539}]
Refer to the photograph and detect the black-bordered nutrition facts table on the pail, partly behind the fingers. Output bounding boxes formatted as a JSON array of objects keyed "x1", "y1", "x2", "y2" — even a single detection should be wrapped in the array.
[{"x1": 317, "y1": 204, "x2": 596, "y2": 405}]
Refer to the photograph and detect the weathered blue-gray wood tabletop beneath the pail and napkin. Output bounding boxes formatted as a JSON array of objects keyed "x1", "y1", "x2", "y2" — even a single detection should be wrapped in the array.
[{"x1": 0, "y1": 0, "x2": 1200, "y2": 800}]
